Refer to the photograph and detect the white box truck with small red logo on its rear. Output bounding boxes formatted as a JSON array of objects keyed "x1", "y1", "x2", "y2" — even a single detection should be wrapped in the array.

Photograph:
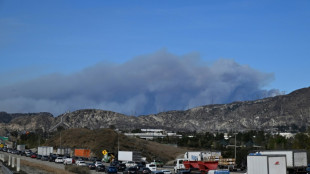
[{"x1": 247, "y1": 154, "x2": 286, "y2": 174}]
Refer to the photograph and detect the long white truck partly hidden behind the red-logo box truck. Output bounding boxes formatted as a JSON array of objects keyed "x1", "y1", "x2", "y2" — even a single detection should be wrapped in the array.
[{"x1": 257, "y1": 150, "x2": 308, "y2": 174}]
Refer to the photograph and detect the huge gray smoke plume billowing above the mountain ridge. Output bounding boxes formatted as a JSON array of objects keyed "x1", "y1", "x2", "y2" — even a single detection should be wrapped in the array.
[{"x1": 0, "y1": 50, "x2": 279, "y2": 115}]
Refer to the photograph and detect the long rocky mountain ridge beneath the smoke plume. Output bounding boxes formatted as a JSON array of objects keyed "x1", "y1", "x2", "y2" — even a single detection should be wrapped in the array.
[{"x1": 0, "y1": 88, "x2": 310, "y2": 132}]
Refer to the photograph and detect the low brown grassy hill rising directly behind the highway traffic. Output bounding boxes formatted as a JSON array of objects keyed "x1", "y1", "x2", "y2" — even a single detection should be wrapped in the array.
[{"x1": 45, "y1": 128, "x2": 186, "y2": 162}]
